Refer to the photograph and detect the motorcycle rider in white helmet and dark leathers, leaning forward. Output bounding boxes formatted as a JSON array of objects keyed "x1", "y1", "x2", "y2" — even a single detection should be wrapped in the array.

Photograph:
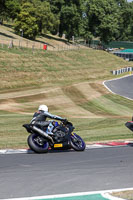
[{"x1": 30, "y1": 105, "x2": 67, "y2": 134}]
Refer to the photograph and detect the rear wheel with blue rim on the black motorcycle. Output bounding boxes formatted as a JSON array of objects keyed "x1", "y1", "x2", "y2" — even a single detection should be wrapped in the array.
[{"x1": 27, "y1": 133, "x2": 49, "y2": 153}]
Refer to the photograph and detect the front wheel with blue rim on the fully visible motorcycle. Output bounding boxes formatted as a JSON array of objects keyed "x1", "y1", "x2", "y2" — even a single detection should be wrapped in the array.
[{"x1": 70, "y1": 133, "x2": 86, "y2": 151}]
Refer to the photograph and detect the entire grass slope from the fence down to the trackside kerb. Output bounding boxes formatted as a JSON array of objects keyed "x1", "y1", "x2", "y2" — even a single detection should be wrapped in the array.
[{"x1": 0, "y1": 24, "x2": 133, "y2": 148}]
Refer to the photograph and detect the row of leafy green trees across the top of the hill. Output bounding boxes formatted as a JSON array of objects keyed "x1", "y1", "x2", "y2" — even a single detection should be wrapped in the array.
[{"x1": 0, "y1": 0, "x2": 133, "y2": 43}]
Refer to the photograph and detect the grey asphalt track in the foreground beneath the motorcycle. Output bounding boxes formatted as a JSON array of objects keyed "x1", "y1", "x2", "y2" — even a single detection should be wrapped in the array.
[{"x1": 0, "y1": 146, "x2": 133, "y2": 199}]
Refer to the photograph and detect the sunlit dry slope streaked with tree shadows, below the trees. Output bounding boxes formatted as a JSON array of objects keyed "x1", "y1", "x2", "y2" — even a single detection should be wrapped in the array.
[{"x1": 0, "y1": 24, "x2": 76, "y2": 51}]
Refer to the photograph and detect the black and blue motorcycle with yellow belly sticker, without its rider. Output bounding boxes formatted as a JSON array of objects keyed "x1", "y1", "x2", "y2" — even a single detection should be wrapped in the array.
[{"x1": 23, "y1": 121, "x2": 86, "y2": 153}]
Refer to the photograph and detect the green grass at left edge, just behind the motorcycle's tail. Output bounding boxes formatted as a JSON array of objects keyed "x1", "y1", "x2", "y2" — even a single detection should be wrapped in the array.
[{"x1": 0, "y1": 112, "x2": 30, "y2": 148}]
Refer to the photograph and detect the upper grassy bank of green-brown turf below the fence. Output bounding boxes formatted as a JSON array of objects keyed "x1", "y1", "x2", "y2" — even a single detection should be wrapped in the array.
[{"x1": 0, "y1": 48, "x2": 129, "y2": 90}]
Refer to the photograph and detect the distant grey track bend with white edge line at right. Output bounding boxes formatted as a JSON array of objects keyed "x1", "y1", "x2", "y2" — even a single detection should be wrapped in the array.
[{"x1": 104, "y1": 75, "x2": 133, "y2": 99}]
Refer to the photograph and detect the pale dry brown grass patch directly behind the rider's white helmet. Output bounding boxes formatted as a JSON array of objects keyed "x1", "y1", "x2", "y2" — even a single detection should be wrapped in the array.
[{"x1": 0, "y1": 88, "x2": 97, "y2": 118}]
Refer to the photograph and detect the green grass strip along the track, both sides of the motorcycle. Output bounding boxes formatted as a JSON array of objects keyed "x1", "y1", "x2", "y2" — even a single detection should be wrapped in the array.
[{"x1": 0, "y1": 113, "x2": 133, "y2": 148}]
